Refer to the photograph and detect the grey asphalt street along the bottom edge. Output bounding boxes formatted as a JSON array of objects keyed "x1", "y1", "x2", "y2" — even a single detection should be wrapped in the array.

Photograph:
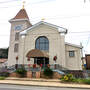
[{"x1": 0, "y1": 84, "x2": 89, "y2": 90}]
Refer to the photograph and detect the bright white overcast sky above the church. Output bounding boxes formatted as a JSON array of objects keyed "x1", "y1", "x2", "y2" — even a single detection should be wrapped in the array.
[{"x1": 0, "y1": 0, "x2": 90, "y2": 53}]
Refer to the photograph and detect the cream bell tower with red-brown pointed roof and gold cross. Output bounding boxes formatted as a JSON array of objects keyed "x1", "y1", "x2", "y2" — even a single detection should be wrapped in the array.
[{"x1": 8, "y1": 5, "x2": 32, "y2": 66}]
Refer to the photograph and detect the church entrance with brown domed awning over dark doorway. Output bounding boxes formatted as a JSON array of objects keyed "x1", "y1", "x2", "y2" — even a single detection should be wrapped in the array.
[{"x1": 26, "y1": 49, "x2": 49, "y2": 67}]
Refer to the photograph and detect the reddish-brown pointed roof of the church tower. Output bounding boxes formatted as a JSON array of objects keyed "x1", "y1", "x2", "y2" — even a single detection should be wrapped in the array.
[{"x1": 13, "y1": 9, "x2": 29, "y2": 20}]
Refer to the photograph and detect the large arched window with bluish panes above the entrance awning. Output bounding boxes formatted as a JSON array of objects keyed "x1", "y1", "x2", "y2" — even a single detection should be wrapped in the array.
[{"x1": 35, "y1": 36, "x2": 49, "y2": 51}]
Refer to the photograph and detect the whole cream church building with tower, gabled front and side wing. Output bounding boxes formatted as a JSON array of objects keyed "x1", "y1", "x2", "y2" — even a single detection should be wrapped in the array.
[{"x1": 8, "y1": 9, "x2": 82, "y2": 70}]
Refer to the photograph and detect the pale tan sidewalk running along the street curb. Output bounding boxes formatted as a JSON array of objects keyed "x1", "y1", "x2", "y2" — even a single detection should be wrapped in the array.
[{"x1": 0, "y1": 78, "x2": 90, "y2": 89}]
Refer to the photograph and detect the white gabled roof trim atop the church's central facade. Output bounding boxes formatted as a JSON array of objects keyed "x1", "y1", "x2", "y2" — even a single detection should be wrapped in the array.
[{"x1": 20, "y1": 21, "x2": 67, "y2": 34}]
